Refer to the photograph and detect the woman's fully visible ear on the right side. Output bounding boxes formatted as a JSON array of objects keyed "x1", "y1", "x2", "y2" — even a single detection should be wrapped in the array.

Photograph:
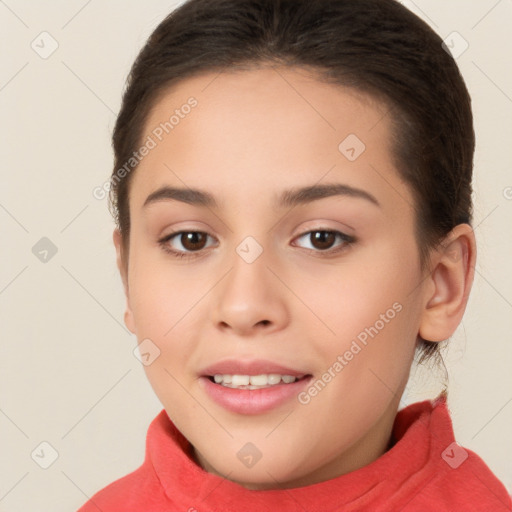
[{"x1": 418, "y1": 224, "x2": 476, "y2": 341}]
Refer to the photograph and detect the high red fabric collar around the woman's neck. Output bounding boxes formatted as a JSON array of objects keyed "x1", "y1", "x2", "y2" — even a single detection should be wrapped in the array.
[{"x1": 145, "y1": 396, "x2": 454, "y2": 512}]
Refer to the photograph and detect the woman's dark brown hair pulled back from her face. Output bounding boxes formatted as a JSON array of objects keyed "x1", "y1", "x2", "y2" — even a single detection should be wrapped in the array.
[{"x1": 109, "y1": 0, "x2": 475, "y2": 360}]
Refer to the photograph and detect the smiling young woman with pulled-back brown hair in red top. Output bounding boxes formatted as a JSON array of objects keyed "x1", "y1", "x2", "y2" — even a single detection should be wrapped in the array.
[{"x1": 80, "y1": 0, "x2": 512, "y2": 512}]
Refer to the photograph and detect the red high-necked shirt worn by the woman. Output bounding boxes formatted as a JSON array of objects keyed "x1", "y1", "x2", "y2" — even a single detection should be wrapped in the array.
[{"x1": 78, "y1": 398, "x2": 512, "y2": 512}]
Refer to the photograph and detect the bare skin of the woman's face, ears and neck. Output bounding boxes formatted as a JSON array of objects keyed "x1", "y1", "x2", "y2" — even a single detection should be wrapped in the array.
[{"x1": 114, "y1": 67, "x2": 476, "y2": 489}]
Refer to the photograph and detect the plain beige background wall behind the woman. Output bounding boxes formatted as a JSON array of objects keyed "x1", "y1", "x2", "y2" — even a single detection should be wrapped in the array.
[{"x1": 0, "y1": 0, "x2": 512, "y2": 512}]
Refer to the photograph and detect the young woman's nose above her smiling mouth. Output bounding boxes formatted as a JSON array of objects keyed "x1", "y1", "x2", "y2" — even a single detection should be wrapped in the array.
[{"x1": 213, "y1": 247, "x2": 290, "y2": 336}]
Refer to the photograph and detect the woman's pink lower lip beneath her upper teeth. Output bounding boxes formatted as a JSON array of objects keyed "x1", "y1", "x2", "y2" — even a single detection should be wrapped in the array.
[{"x1": 199, "y1": 376, "x2": 312, "y2": 414}]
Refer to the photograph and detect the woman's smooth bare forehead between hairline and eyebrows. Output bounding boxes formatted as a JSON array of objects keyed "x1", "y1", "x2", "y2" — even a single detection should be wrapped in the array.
[{"x1": 131, "y1": 67, "x2": 412, "y2": 216}]
